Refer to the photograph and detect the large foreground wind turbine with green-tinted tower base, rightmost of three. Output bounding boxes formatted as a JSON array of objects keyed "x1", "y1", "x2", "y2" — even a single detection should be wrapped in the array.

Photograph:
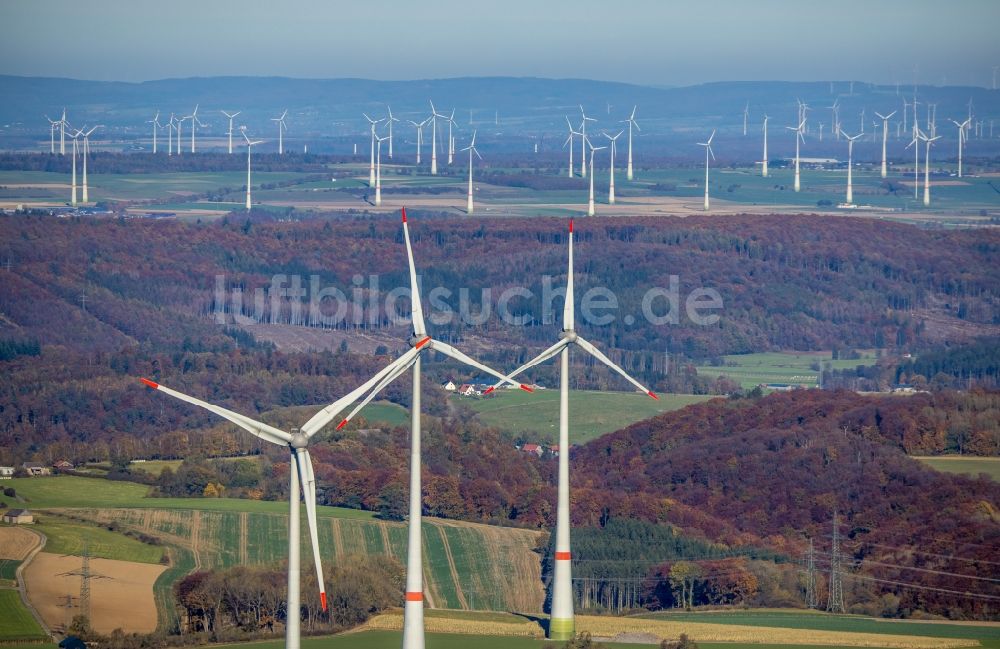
[{"x1": 486, "y1": 219, "x2": 659, "y2": 640}]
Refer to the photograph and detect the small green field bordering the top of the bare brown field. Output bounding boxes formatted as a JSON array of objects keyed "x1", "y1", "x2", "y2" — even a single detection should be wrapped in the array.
[{"x1": 34, "y1": 514, "x2": 164, "y2": 563}]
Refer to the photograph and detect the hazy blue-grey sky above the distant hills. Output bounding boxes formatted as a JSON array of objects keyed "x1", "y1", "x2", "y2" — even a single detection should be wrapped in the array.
[{"x1": 0, "y1": 0, "x2": 1000, "y2": 85}]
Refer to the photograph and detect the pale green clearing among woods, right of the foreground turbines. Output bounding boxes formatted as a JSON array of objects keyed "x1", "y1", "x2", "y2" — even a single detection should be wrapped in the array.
[{"x1": 698, "y1": 352, "x2": 876, "y2": 389}]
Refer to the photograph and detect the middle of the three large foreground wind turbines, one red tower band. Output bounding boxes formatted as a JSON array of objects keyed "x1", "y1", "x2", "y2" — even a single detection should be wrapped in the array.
[{"x1": 330, "y1": 208, "x2": 531, "y2": 649}]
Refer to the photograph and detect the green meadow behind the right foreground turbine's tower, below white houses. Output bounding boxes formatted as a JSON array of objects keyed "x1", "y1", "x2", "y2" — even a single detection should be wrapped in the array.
[{"x1": 460, "y1": 389, "x2": 711, "y2": 444}]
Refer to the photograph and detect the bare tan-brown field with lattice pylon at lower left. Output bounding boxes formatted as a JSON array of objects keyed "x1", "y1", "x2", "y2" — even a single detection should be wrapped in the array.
[{"x1": 24, "y1": 552, "x2": 166, "y2": 633}]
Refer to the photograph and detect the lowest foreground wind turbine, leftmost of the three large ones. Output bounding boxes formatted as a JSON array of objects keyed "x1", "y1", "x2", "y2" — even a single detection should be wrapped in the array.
[{"x1": 139, "y1": 368, "x2": 414, "y2": 649}]
